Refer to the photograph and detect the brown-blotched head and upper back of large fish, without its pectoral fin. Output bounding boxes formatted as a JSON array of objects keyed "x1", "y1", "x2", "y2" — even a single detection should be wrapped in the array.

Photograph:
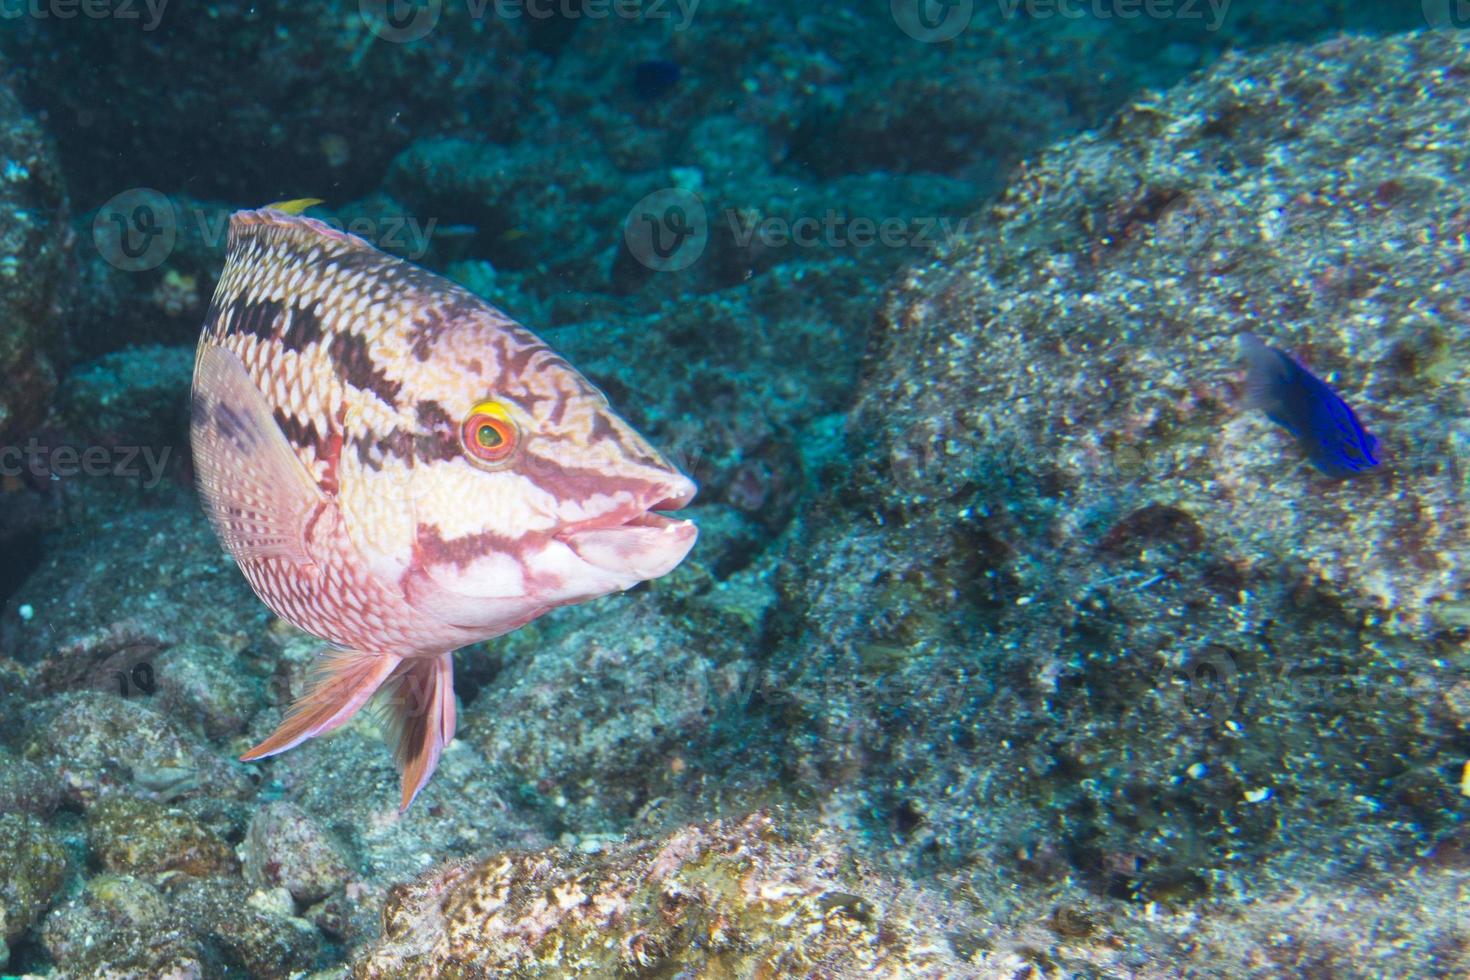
[{"x1": 207, "y1": 212, "x2": 697, "y2": 635}]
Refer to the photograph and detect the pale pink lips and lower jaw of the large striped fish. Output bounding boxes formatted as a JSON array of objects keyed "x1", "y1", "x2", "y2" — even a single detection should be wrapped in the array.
[{"x1": 556, "y1": 479, "x2": 700, "y2": 585}]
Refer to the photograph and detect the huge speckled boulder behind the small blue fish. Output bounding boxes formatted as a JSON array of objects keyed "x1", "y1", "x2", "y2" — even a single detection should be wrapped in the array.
[{"x1": 761, "y1": 35, "x2": 1470, "y2": 901}]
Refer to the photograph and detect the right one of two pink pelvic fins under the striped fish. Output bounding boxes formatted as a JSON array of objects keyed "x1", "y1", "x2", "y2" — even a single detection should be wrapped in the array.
[{"x1": 384, "y1": 654, "x2": 456, "y2": 811}]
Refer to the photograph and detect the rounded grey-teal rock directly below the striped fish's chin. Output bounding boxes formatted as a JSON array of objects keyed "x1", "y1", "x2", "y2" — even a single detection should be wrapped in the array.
[{"x1": 462, "y1": 552, "x2": 775, "y2": 835}]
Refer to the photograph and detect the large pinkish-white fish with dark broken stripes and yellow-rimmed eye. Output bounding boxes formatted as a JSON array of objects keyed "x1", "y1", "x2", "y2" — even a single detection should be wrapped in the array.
[{"x1": 190, "y1": 209, "x2": 697, "y2": 808}]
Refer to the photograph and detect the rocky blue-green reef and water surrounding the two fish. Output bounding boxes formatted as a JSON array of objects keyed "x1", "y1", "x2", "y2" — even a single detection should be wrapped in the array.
[{"x1": 0, "y1": 0, "x2": 1470, "y2": 979}]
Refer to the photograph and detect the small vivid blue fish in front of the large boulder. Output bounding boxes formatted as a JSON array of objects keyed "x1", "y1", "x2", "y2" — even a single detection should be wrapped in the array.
[{"x1": 1235, "y1": 334, "x2": 1379, "y2": 479}]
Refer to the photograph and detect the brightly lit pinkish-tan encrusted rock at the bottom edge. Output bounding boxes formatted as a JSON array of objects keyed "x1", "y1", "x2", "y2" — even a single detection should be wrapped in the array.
[{"x1": 354, "y1": 813, "x2": 963, "y2": 979}]
